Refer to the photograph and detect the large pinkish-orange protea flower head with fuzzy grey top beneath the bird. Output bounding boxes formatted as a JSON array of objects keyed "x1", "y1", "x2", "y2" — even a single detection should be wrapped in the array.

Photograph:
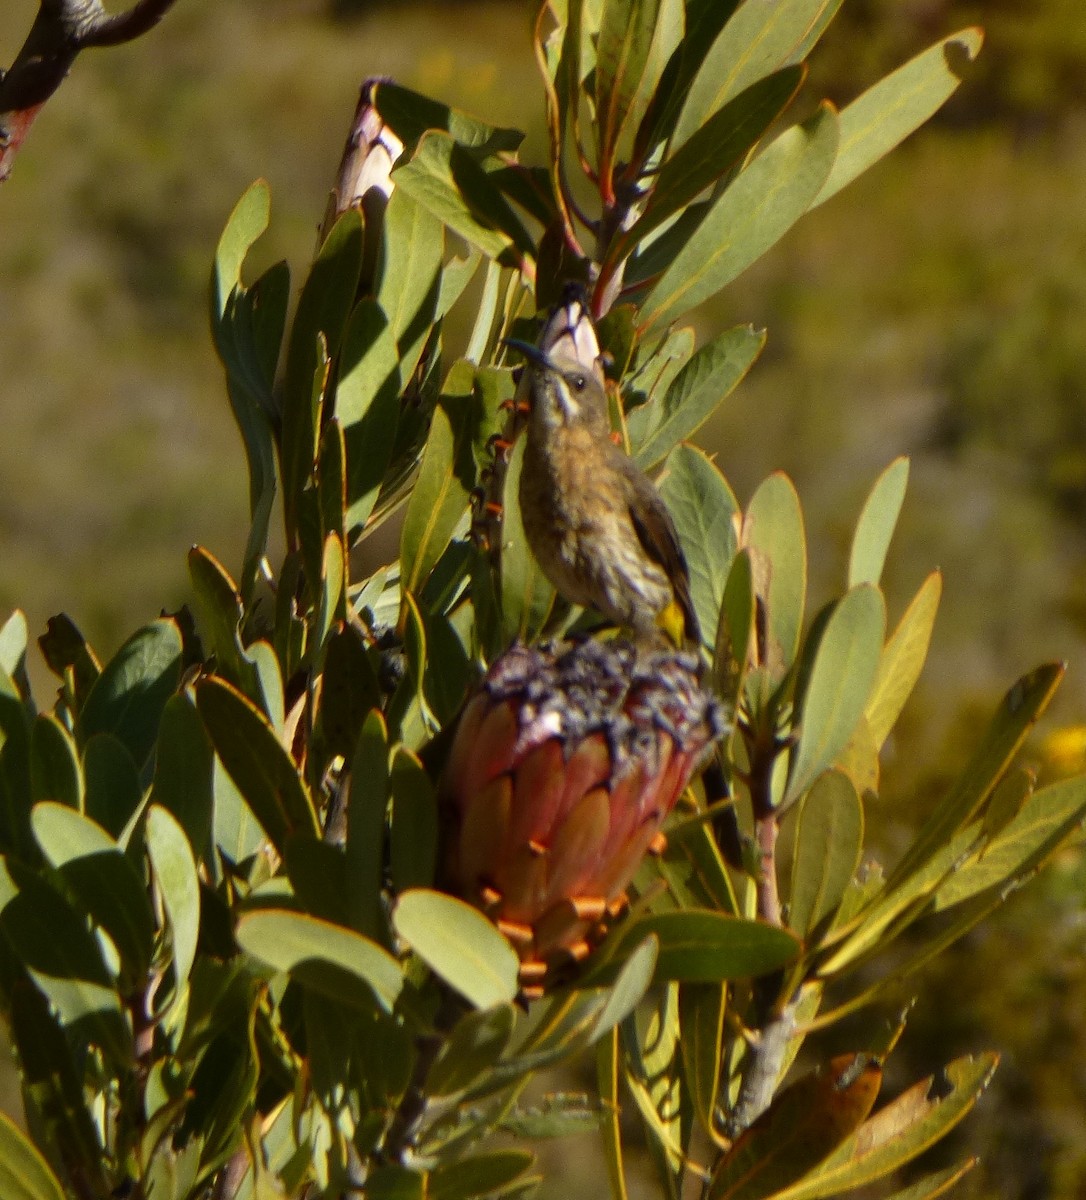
[{"x1": 442, "y1": 640, "x2": 724, "y2": 995}]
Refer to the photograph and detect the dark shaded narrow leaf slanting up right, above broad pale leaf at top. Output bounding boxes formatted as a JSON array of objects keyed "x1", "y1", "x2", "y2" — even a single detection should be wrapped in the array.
[{"x1": 608, "y1": 66, "x2": 805, "y2": 262}]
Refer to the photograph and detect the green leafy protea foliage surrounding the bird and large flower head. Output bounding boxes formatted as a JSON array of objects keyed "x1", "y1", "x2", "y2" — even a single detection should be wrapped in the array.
[{"x1": 0, "y1": 0, "x2": 1086, "y2": 1200}]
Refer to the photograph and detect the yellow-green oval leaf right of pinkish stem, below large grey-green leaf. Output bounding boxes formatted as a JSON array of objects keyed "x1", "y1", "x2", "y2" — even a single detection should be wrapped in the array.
[{"x1": 788, "y1": 770, "x2": 864, "y2": 937}]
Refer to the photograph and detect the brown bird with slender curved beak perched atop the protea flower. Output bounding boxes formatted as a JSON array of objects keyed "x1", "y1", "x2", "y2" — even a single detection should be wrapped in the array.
[{"x1": 506, "y1": 305, "x2": 701, "y2": 649}]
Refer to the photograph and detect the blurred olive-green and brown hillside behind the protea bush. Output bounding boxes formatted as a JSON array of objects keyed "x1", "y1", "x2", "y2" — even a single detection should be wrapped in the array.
[{"x1": 0, "y1": 0, "x2": 1086, "y2": 1200}]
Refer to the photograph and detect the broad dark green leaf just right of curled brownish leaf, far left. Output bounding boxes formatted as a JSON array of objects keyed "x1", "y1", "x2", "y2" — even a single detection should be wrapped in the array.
[{"x1": 79, "y1": 618, "x2": 181, "y2": 767}]
